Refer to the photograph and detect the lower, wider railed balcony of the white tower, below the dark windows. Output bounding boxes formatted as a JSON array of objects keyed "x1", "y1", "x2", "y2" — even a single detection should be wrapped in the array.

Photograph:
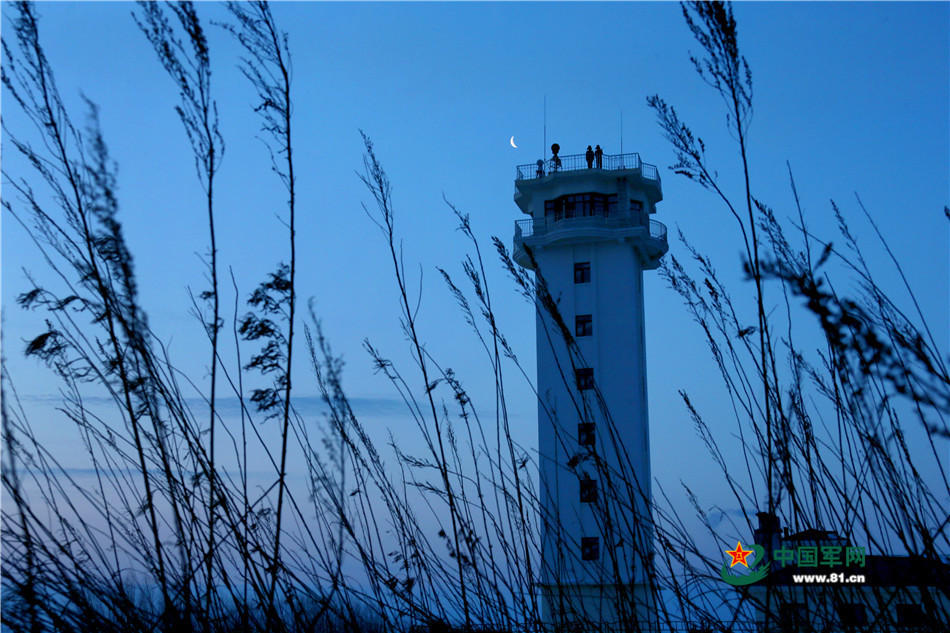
[{"x1": 513, "y1": 212, "x2": 669, "y2": 270}]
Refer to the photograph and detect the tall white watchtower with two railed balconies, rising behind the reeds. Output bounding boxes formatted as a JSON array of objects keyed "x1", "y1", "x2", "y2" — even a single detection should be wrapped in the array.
[{"x1": 514, "y1": 146, "x2": 668, "y2": 631}]
